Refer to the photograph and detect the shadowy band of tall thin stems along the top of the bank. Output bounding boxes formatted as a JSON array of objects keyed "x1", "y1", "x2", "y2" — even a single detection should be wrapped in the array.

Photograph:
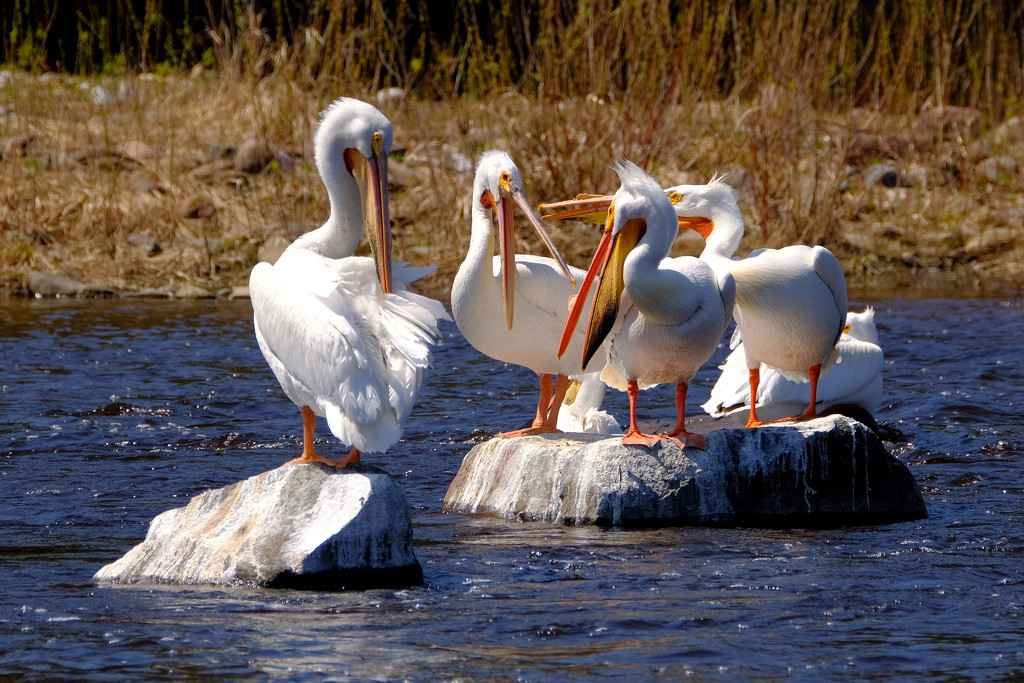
[{"x1": 6, "y1": 0, "x2": 1024, "y2": 119}]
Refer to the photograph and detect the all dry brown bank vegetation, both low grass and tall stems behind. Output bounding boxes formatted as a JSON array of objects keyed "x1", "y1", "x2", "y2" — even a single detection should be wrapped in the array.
[{"x1": 0, "y1": 0, "x2": 1024, "y2": 299}]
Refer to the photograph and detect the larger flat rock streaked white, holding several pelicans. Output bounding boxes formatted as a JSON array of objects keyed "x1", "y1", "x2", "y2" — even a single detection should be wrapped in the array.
[{"x1": 444, "y1": 415, "x2": 928, "y2": 527}]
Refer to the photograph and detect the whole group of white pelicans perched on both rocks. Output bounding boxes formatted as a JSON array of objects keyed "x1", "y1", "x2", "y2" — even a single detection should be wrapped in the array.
[{"x1": 250, "y1": 98, "x2": 882, "y2": 467}]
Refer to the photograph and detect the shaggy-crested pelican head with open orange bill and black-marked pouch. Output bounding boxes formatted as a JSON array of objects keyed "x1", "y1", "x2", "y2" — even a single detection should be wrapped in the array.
[{"x1": 558, "y1": 161, "x2": 678, "y2": 367}]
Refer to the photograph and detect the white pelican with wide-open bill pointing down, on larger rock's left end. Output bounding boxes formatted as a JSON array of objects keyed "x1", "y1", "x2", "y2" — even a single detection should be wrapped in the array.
[{"x1": 452, "y1": 151, "x2": 599, "y2": 437}]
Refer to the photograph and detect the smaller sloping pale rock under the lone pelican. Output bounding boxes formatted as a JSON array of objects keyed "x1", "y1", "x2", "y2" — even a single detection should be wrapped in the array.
[{"x1": 93, "y1": 464, "x2": 423, "y2": 590}]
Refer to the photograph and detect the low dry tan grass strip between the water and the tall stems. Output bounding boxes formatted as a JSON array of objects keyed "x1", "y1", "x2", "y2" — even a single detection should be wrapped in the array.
[{"x1": 0, "y1": 68, "x2": 1024, "y2": 300}]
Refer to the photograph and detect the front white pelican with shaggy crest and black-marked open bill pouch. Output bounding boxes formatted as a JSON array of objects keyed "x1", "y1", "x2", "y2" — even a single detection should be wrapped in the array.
[{"x1": 558, "y1": 162, "x2": 735, "y2": 449}]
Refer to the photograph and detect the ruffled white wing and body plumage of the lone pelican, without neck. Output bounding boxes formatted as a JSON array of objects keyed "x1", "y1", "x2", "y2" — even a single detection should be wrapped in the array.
[{"x1": 250, "y1": 254, "x2": 446, "y2": 452}]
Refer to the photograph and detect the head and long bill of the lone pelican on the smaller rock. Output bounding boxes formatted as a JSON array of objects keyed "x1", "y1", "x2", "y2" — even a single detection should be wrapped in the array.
[{"x1": 313, "y1": 97, "x2": 393, "y2": 293}]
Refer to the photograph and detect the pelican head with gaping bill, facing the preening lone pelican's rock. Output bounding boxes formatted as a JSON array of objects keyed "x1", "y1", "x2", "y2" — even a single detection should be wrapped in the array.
[{"x1": 473, "y1": 150, "x2": 575, "y2": 330}]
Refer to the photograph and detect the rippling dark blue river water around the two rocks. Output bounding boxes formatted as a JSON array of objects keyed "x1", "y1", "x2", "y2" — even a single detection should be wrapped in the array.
[{"x1": 0, "y1": 298, "x2": 1024, "y2": 681}]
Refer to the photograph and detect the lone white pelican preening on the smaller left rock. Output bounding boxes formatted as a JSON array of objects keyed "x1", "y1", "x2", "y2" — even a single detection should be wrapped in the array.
[{"x1": 249, "y1": 98, "x2": 447, "y2": 467}]
